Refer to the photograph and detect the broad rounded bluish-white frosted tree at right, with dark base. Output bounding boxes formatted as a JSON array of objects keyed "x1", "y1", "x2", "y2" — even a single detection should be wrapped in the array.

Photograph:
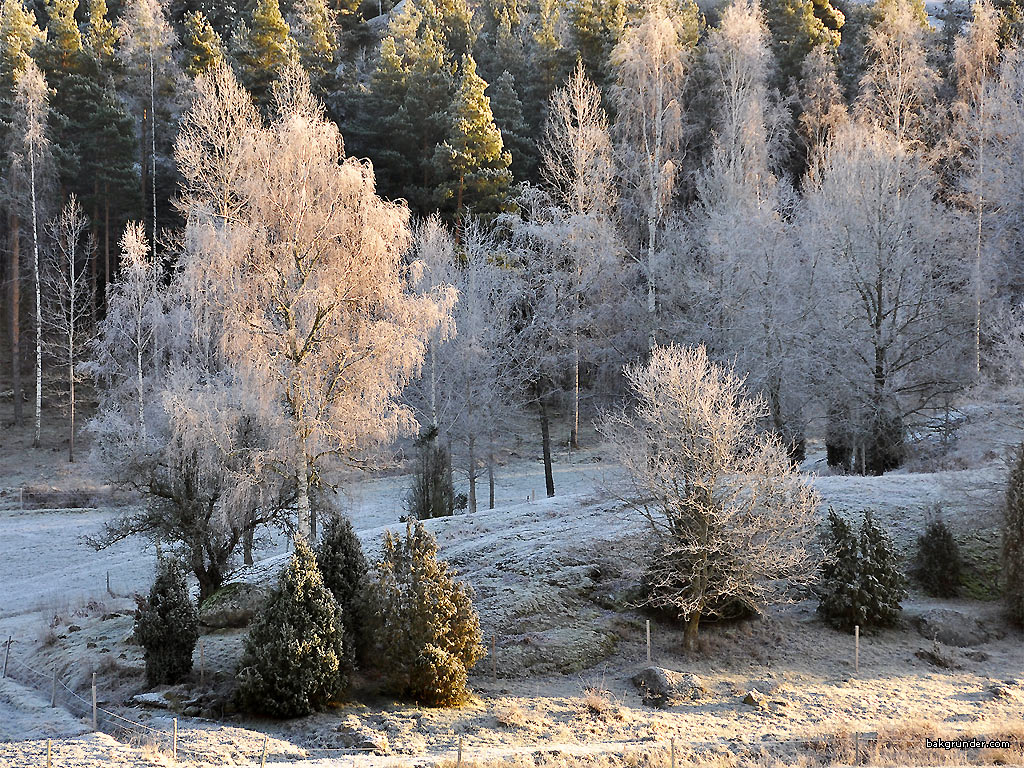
[{"x1": 802, "y1": 124, "x2": 967, "y2": 474}]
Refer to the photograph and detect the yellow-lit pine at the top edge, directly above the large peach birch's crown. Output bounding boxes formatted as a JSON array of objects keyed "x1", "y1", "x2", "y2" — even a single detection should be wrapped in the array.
[{"x1": 231, "y1": 0, "x2": 296, "y2": 106}]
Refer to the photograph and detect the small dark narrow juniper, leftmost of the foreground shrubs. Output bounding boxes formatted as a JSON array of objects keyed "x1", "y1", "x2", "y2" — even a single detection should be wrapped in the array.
[{"x1": 135, "y1": 559, "x2": 199, "y2": 685}]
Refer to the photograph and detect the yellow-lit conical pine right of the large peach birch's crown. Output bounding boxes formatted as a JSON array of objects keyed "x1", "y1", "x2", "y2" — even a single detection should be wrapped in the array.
[{"x1": 436, "y1": 56, "x2": 512, "y2": 220}]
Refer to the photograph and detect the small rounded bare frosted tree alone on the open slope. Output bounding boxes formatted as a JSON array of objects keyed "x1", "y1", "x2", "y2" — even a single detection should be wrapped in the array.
[{"x1": 599, "y1": 346, "x2": 818, "y2": 648}]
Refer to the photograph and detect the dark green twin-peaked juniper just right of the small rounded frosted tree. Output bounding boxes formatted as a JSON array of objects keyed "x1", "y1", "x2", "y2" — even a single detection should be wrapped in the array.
[{"x1": 818, "y1": 510, "x2": 906, "y2": 631}]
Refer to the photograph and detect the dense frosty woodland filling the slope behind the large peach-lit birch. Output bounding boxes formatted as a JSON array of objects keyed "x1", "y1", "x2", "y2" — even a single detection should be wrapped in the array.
[{"x1": 0, "y1": 0, "x2": 1024, "y2": 507}]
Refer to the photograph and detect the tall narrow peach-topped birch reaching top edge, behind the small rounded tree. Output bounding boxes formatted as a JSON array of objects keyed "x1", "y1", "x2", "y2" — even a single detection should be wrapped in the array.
[{"x1": 611, "y1": 2, "x2": 702, "y2": 344}]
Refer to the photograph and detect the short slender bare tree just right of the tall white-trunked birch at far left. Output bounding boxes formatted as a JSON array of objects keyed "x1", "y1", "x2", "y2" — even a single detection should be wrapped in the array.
[{"x1": 42, "y1": 195, "x2": 95, "y2": 462}]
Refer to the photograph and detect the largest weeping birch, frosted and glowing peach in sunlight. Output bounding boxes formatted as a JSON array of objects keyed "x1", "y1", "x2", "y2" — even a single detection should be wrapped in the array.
[{"x1": 177, "y1": 68, "x2": 453, "y2": 538}]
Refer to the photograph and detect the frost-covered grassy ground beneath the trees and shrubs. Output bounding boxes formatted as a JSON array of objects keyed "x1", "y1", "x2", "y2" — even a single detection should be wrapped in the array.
[{"x1": 0, "y1": 393, "x2": 1024, "y2": 768}]
